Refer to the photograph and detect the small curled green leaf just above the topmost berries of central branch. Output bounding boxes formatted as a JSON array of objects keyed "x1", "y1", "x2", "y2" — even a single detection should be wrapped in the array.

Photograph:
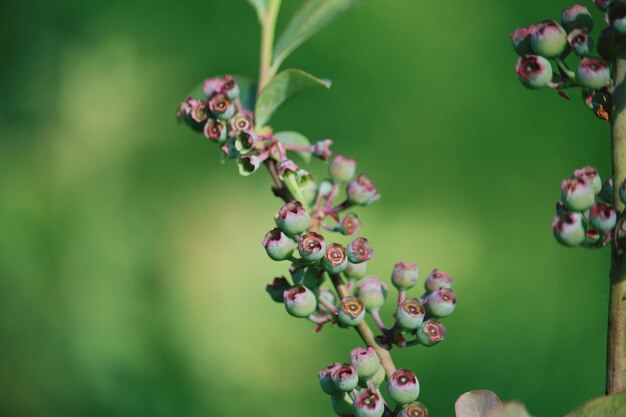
[{"x1": 254, "y1": 69, "x2": 331, "y2": 127}]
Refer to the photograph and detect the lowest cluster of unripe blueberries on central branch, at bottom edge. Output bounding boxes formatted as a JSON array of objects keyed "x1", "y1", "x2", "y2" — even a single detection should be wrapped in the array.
[{"x1": 318, "y1": 347, "x2": 428, "y2": 417}]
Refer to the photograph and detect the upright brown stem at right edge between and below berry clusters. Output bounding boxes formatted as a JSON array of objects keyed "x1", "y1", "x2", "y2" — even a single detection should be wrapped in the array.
[{"x1": 606, "y1": 38, "x2": 626, "y2": 394}]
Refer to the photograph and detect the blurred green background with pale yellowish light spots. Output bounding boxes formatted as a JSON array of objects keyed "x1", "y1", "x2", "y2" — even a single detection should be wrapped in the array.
[{"x1": 0, "y1": 0, "x2": 610, "y2": 417}]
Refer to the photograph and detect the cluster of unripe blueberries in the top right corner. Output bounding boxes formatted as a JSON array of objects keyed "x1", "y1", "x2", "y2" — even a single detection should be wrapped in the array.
[{"x1": 511, "y1": 0, "x2": 626, "y2": 120}]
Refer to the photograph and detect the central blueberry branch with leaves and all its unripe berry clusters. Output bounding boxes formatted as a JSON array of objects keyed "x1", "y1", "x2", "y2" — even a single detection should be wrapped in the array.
[{"x1": 177, "y1": 0, "x2": 457, "y2": 417}]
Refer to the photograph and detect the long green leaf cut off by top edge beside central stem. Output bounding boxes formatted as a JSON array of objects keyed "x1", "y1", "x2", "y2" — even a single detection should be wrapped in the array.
[{"x1": 273, "y1": 0, "x2": 364, "y2": 68}]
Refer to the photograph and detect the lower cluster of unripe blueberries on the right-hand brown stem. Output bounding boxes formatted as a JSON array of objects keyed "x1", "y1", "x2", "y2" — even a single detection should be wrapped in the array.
[{"x1": 552, "y1": 166, "x2": 626, "y2": 248}]
